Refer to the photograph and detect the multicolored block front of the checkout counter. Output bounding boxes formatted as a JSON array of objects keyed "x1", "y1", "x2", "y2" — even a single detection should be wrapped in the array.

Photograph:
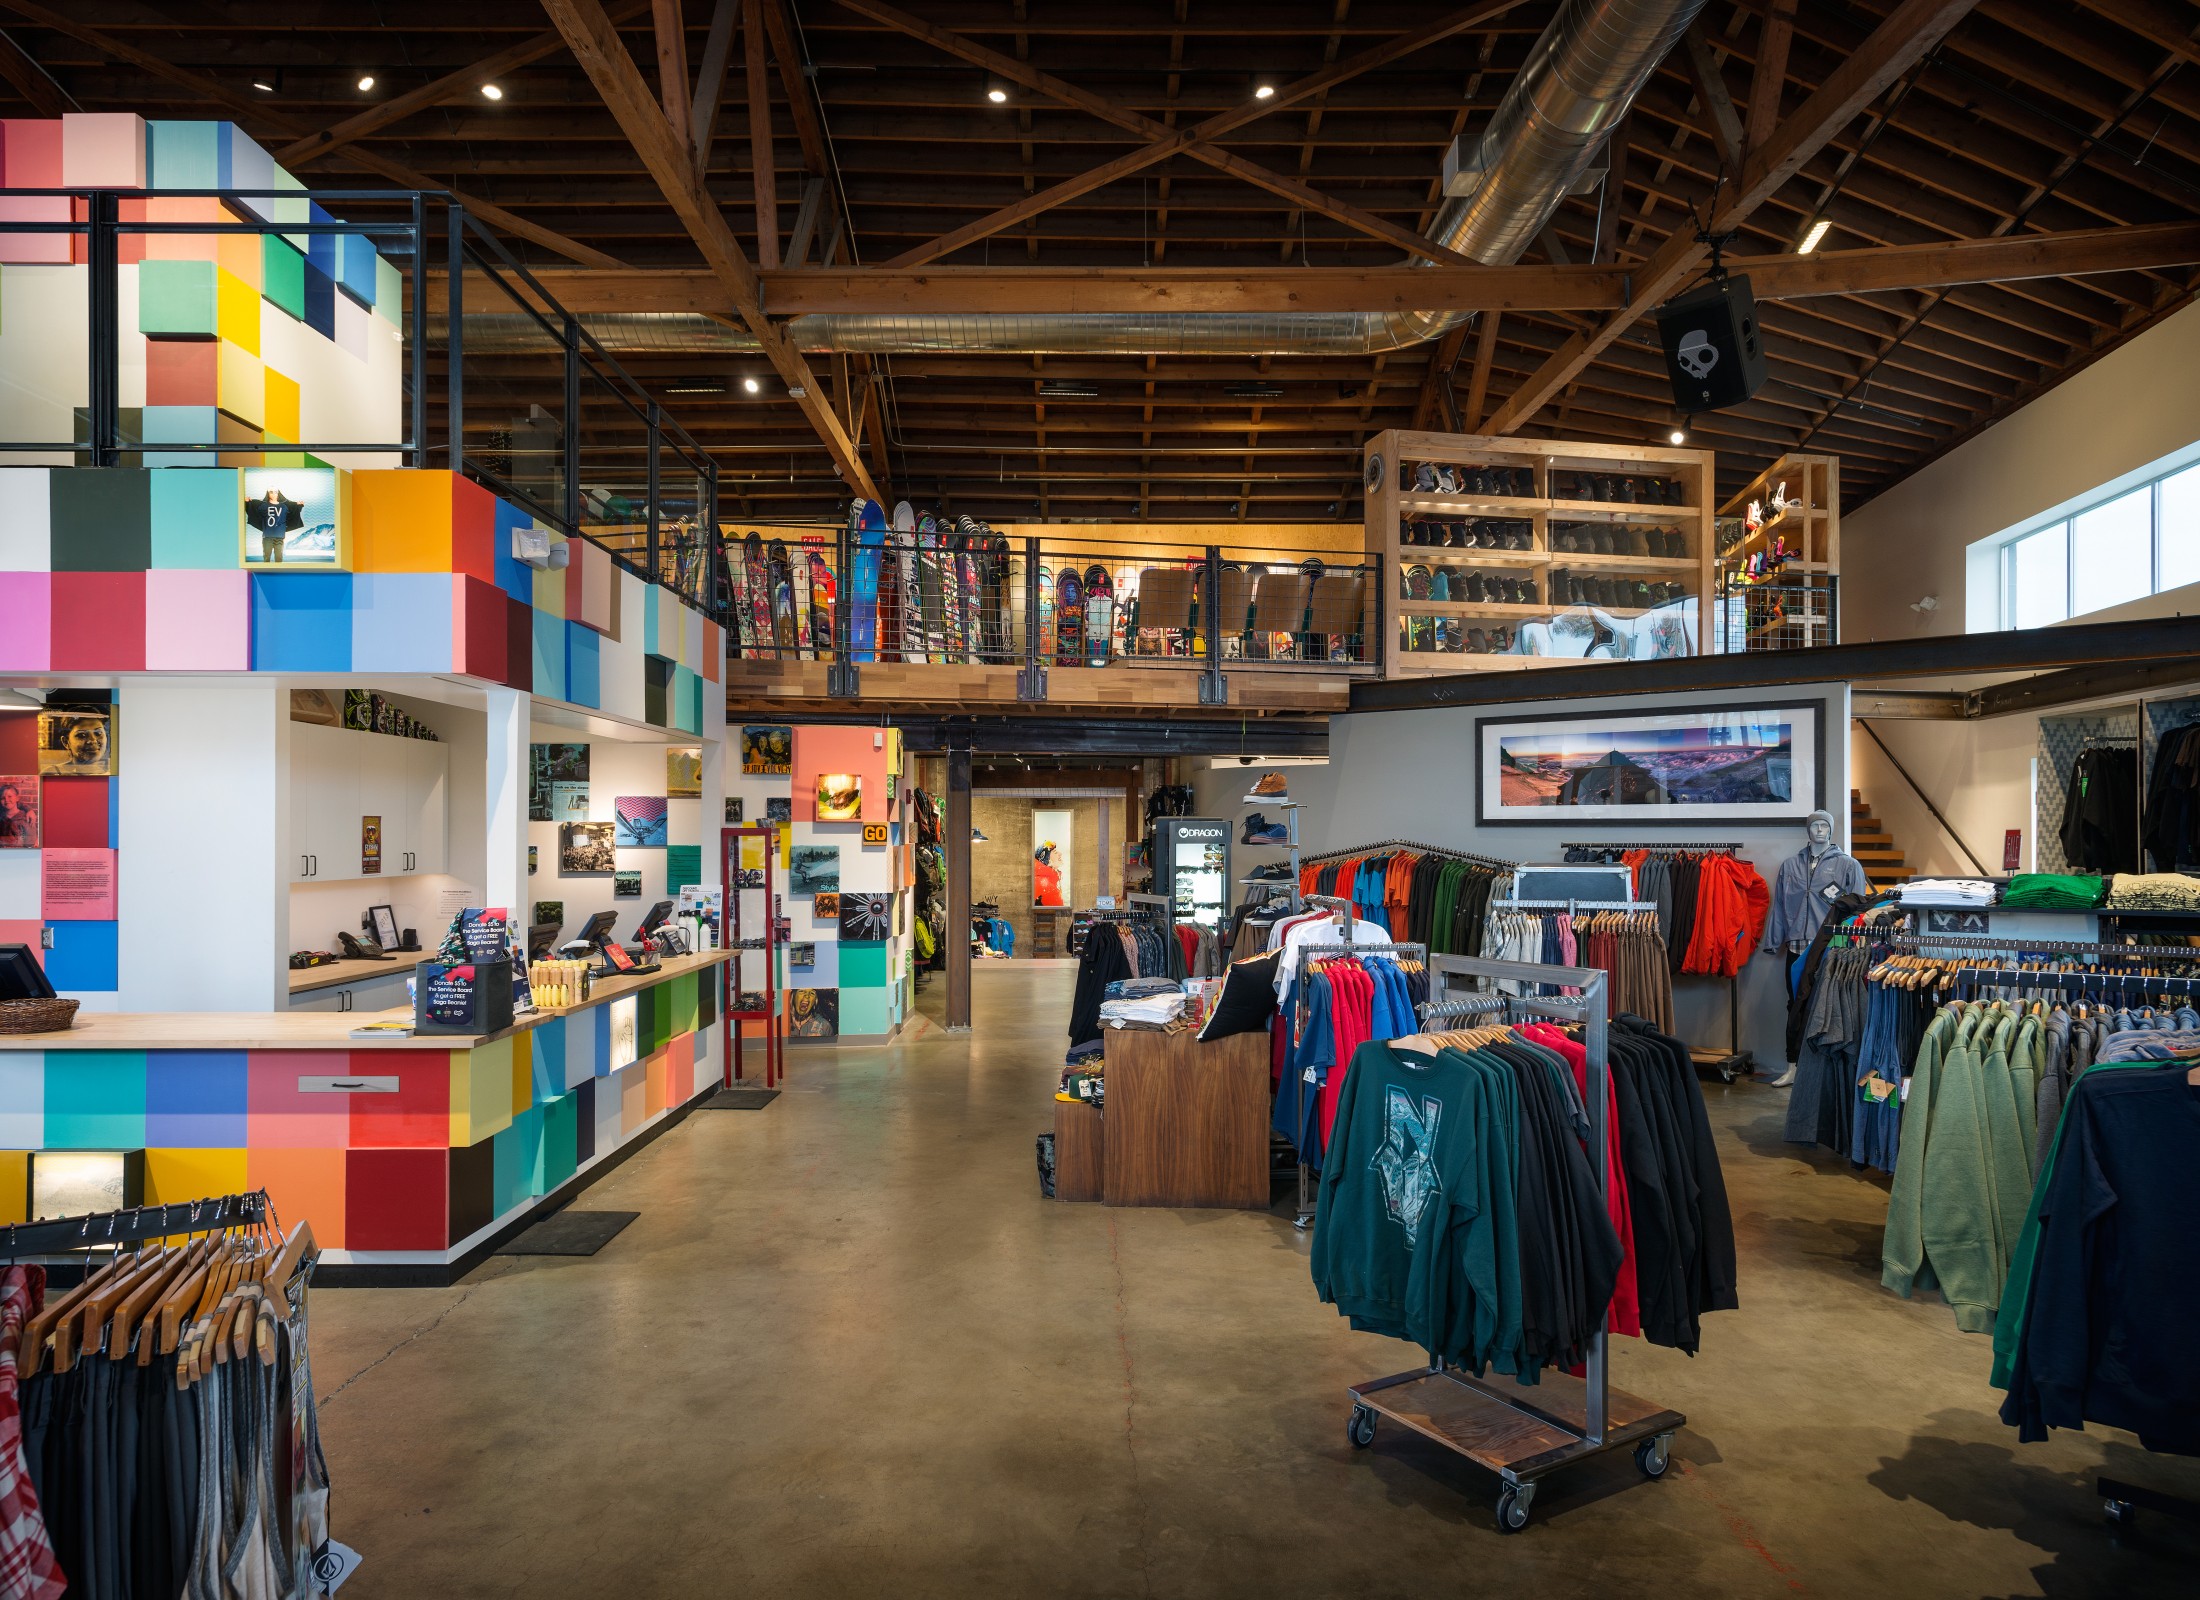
[{"x1": 0, "y1": 968, "x2": 719, "y2": 1261}]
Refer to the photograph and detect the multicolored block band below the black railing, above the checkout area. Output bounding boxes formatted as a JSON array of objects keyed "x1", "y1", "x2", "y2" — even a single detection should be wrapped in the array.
[{"x1": 0, "y1": 467, "x2": 726, "y2": 733}]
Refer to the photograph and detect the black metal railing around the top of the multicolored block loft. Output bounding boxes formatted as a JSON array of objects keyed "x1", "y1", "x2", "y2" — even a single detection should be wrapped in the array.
[{"x1": 0, "y1": 189, "x2": 728, "y2": 621}]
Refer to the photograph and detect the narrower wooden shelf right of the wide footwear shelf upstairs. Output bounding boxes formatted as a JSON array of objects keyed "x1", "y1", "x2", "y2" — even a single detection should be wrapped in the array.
[{"x1": 1705, "y1": 453, "x2": 1841, "y2": 654}]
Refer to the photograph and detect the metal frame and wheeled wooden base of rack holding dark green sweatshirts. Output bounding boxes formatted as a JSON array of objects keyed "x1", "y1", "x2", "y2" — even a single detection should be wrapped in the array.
[{"x1": 1346, "y1": 959, "x2": 1687, "y2": 1534}]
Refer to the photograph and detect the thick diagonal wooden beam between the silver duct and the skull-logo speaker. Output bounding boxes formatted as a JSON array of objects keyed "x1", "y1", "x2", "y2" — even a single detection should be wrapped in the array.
[{"x1": 1485, "y1": 0, "x2": 1973, "y2": 434}]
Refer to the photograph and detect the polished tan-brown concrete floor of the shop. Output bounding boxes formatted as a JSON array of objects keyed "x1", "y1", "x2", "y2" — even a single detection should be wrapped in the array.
[{"x1": 312, "y1": 964, "x2": 2200, "y2": 1600}]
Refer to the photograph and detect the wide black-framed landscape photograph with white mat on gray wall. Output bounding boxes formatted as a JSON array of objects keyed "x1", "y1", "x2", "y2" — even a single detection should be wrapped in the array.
[{"x1": 1474, "y1": 700, "x2": 1826, "y2": 828}]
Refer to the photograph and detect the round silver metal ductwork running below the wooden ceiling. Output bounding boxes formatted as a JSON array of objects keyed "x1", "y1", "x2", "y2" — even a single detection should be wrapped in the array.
[{"x1": 466, "y1": 0, "x2": 1705, "y2": 357}]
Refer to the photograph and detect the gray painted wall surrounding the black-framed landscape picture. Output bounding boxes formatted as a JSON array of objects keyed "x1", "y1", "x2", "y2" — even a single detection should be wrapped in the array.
[{"x1": 1289, "y1": 682, "x2": 1848, "y2": 1063}]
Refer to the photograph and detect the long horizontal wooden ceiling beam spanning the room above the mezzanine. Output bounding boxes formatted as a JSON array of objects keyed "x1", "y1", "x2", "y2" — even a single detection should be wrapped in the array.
[{"x1": 429, "y1": 220, "x2": 2200, "y2": 317}]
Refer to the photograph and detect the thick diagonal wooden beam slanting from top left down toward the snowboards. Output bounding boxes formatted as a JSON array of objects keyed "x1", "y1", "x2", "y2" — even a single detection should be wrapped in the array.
[{"x1": 543, "y1": 0, "x2": 882, "y2": 500}]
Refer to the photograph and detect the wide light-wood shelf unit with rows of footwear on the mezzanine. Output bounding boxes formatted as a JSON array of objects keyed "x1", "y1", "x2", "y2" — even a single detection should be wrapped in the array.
[{"x1": 1364, "y1": 429, "x2": 1714, "y2": 678}]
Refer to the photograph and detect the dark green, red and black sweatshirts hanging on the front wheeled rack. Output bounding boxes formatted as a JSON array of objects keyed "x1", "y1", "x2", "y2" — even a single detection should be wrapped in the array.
[{"x1": 1311, "y1": 1012, "x2": 1736, "y2": 1384}]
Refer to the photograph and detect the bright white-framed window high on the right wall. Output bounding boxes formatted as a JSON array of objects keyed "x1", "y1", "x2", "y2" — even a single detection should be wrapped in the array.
[{"x1": 2006, "y1": 464, "x2": 2200, "y2": 627}]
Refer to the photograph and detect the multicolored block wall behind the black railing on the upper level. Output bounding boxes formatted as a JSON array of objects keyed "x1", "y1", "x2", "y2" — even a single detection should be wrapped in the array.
[{"x1": 0, "y1": 112, "x2": 403, "y2": 467}]
